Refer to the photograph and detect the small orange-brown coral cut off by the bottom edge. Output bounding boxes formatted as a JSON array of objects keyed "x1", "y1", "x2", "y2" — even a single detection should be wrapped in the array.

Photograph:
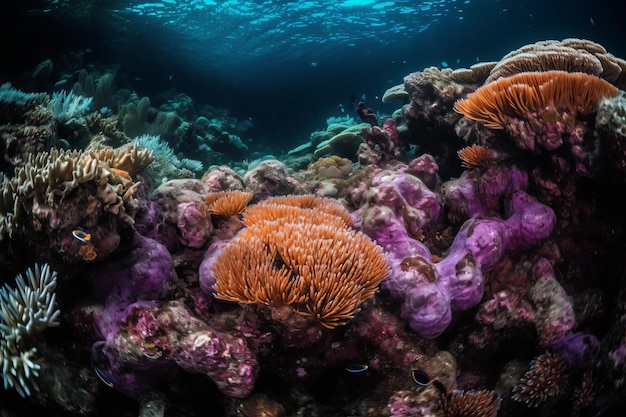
[{"x1": 446, "y1": 390, "x2": 502, "y2": 417}]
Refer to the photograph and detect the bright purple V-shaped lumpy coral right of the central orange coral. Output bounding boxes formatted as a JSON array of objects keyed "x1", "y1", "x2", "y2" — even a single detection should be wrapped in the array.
[{"x1": 356, "y1": 164, "x2": 556, "y2": 338}]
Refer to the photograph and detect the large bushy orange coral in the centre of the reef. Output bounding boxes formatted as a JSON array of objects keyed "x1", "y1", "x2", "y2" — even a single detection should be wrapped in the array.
[{"x1": 213, "y1": 196, "x2": 388, "y2": 329}]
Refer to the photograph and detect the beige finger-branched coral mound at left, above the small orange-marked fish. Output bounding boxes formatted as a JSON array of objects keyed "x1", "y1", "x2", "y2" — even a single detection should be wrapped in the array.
[{"x1": 0, "y1": 144, "x2": 153, "y2": 262}]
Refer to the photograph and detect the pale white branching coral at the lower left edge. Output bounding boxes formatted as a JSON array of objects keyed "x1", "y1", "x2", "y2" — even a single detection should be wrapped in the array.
[{"x1": 0, "y1": 264, "x2": 61, "y2": 397}]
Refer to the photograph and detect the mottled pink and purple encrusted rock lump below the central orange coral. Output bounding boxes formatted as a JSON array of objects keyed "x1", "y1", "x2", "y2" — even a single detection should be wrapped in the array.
[{"x1": 93, "y1": 301, "x2": 259, "y2": 398}]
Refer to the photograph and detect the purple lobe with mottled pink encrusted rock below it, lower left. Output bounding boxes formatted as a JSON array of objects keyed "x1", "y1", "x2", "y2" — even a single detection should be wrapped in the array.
[{"x1": 86, "y1": 234, "x2": 258, "y2": 397}]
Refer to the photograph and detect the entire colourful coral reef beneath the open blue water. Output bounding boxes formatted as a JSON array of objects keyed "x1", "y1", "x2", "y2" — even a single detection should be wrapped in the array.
[{"x1": 0, "y1": 39, "x2": 626, "y2": 417}]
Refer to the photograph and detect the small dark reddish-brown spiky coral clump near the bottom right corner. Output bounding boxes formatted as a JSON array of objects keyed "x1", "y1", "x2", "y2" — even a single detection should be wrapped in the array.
[{"x1": 511, "y1": 352, "x2": 567, "y2": 407}]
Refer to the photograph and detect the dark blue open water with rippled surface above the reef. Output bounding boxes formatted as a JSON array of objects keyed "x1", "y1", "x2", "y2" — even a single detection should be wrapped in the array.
[{"x1": 0, "y1": 0, "x2": 626, "y2": 148}]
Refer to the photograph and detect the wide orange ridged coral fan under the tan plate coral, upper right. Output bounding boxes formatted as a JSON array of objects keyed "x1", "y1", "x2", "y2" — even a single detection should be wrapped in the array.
[{"x1": 454, "y1": 71, "x2": 619, "y2": 129}]
